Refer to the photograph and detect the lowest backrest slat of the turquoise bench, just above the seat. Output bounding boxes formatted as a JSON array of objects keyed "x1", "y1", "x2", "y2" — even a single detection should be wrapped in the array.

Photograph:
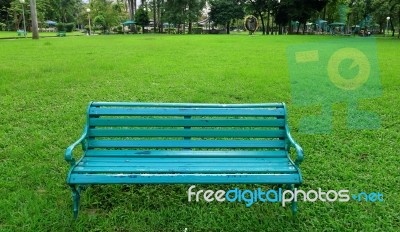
[{"x1": 88, "y1": 140, "x2": 285, "y2": 148}]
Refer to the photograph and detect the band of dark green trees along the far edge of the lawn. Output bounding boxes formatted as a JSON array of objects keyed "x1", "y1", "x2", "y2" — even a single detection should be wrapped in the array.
[{"x1": 0, "y1": 0, "x2": 400, "y2": 34}]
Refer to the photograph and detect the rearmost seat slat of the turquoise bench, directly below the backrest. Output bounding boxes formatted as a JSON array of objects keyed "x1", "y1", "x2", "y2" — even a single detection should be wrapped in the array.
[{"x1": 85, "y1": 150, "x2": 287, "y2": 158}]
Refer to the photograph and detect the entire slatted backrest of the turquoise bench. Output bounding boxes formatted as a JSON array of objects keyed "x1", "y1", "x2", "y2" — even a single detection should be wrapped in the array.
[{"x1": 88, "y1": 102, "x2": 286, "y2": 150}]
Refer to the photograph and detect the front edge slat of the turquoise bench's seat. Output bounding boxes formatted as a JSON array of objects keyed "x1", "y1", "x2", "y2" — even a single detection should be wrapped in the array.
[{"x1": 68, "y1": 173, "x2": 301, "y2": 184}]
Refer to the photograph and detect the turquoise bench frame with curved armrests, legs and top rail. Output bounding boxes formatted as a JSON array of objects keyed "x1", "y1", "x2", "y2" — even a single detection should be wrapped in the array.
[{"x1": 64, "y1": 102, "x2": 304, "y2": 219}]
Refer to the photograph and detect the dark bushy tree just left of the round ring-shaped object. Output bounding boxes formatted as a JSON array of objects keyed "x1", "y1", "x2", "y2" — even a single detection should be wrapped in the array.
[{"x1": 209, "y1": 0, "x2": 244, "y2": 34}]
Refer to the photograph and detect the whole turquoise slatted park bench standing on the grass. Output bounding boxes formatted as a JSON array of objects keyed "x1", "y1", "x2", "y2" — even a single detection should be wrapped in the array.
[{"x1": 65, "y1": 102, "x2": 303, "y2": 218}]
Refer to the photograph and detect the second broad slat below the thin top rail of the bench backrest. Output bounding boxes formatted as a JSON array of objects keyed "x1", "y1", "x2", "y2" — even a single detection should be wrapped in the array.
[{"x1": 89, "y1": 118, "x2": 285, "y2": 127}]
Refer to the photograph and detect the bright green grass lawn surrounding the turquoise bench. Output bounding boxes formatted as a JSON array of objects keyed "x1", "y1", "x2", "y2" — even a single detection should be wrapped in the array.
[{"x1": 0, "y1": 33, "x2": 400, "y2": 231}]
